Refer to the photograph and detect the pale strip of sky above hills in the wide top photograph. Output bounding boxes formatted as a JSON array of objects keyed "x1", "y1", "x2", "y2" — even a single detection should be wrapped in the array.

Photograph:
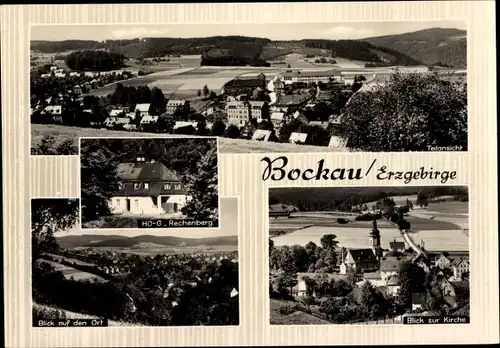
[{"x1": 31, "y1": 21, "x2": 466, "y2": 41}]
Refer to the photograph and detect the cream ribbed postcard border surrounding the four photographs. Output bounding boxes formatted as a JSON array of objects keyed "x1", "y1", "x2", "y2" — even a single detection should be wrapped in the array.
[{"x1": 0, "y1": 1, "x2": 499, "y2": 348}]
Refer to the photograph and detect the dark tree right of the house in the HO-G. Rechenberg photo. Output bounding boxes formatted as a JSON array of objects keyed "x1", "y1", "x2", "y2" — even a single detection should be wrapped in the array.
[{"x1": 181, "y1": 146, "x2": 219, "y2": 220}]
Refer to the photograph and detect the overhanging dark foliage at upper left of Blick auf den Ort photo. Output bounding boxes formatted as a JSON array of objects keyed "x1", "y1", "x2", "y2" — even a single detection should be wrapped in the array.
[{"x1": 31, "y1": 198, "x2": 79, "y2": 261}]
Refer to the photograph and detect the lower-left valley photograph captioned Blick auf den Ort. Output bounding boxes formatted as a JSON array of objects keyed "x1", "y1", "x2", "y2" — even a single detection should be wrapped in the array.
[{"x1": 31, "y1": 197, "x2": 239, "y2": 327}]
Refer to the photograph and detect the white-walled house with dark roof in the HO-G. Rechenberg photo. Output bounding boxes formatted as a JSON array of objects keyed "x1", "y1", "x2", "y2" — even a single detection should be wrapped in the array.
[{"x1": 109, "y1": 156, "x2": 190, "y2": 216}]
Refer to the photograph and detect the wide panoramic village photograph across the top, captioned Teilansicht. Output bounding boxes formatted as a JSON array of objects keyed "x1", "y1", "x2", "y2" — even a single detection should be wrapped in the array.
[{"x1": 30, "y1": 22, "x2": 467, "y2": 155}]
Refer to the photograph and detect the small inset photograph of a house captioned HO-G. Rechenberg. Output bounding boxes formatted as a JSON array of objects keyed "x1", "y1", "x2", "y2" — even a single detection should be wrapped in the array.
[{"x1": 80, "y1": 137, "x2": 220, "y2": 229}]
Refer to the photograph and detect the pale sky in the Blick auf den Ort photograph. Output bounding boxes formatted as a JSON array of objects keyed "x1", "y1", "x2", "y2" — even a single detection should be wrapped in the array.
[{"x1": 54, "y1": 197, "x2": 238, "y2": 238}]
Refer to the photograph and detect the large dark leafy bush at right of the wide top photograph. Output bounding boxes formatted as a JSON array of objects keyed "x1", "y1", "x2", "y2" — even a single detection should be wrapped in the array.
[{"x1": 342, "y1": 72, "x2": 467, "y2": 152}]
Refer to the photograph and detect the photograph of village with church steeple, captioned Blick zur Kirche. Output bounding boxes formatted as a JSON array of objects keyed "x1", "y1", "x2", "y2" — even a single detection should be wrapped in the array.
[{"x1": 269, "y1": 187, "x2": 470, "y2": 325}]
